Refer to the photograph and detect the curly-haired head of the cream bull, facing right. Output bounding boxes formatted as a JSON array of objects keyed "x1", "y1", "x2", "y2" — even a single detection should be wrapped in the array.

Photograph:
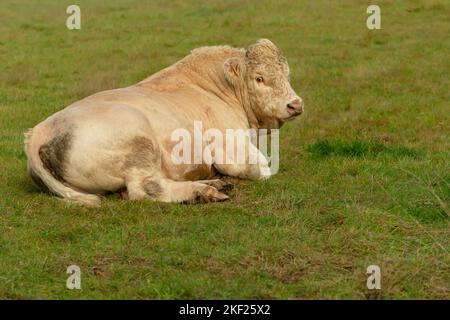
[{"x1": 225, "y1": 39, "x2": 304, "y2": 128}]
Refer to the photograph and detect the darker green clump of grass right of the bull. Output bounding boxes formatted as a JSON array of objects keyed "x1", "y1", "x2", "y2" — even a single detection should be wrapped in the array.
[{"x1": 308, "y1": 139, "x2": 421, "y2": 158}]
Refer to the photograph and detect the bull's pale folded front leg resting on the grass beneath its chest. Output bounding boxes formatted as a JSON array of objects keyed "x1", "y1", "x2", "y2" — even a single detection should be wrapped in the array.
[{"x1": 214, "y1": 144, "x2": 272, "y2": 180}]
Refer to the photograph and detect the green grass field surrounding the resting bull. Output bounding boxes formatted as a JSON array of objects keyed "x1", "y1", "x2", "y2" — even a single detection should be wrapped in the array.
[{"x1": 0, "y1": 0, "x2": 450, "y2": 299}]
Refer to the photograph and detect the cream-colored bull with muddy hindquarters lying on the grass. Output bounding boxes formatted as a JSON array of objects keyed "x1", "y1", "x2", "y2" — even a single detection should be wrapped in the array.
[{"x1": 25, "y1": 39, "x2": 303, "y2": 205}]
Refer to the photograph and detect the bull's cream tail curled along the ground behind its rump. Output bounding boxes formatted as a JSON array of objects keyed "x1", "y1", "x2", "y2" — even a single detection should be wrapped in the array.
[{"x1": 25, "y1": 125, "x2": 101, "y2": 206}]
